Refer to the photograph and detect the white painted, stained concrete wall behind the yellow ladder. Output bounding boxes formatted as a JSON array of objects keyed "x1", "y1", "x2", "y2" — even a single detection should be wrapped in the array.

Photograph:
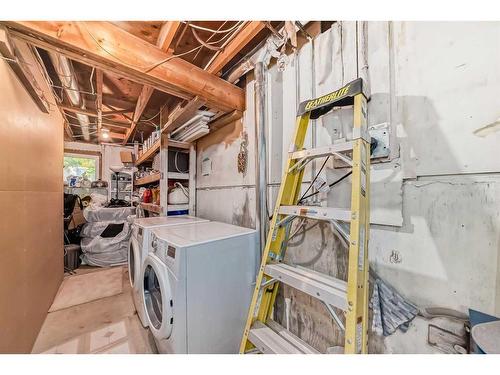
[{"x1": 193, "y1": 22, "x2": 500, "y2": 353}]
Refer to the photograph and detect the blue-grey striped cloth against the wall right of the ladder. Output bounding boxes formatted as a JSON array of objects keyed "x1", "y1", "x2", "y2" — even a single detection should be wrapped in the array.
[{"x1": 370, "y1": 273, "x2": 419, "y2": 336}]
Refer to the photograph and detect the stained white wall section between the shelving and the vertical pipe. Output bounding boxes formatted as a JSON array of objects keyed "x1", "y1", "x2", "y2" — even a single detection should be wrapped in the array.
[{"x1": 196, "y1": 75, "x2": 256, "y2": 228}]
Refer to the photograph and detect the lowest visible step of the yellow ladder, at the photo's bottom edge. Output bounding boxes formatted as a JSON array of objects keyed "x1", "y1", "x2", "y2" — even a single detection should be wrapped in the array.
[{"x1": 248, "y1": 319, "x2": 319, "y2": 354}]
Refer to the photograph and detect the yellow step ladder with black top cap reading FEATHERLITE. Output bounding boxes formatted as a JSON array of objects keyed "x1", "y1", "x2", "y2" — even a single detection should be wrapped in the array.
[{"x1": 240, "y1": 78, "x2": 370, "y2": 354}]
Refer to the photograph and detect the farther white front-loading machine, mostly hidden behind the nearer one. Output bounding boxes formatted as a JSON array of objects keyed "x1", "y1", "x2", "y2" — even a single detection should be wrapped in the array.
[{"x1": 128, "y1": 216, "x2": 208, "y2": 327}]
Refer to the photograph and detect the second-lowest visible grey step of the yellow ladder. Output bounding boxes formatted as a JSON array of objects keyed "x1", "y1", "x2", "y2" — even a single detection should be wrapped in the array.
[{"x1": 264, "y1": 263, "x2": 347, "y2": 310}]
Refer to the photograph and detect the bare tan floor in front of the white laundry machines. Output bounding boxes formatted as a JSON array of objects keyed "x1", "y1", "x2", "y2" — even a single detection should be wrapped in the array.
[{"x1": 32, "y1": 267, "x2": 157, "y2": 354}]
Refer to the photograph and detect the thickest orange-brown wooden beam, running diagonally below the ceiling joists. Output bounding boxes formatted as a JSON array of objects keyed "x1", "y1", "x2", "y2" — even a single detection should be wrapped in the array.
[{"x1": 2, "y1": 21, "x2": 245, "y2": 111}]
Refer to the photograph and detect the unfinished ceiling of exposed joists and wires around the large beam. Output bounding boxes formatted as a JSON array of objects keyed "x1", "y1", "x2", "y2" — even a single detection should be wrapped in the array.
[{"x1": 24, "y1": 21, "x2": 282, "y2": 144}]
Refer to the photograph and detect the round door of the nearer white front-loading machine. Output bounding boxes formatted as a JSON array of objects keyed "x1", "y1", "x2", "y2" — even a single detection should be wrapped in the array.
[{"x1": 142, "y1": 255, "x2": 174, "y2": 340}]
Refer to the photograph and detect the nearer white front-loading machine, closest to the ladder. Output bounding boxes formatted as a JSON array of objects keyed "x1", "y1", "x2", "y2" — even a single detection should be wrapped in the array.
[{"x1": 141, "y1": 221, "x2": 259, "y2": 354}]
